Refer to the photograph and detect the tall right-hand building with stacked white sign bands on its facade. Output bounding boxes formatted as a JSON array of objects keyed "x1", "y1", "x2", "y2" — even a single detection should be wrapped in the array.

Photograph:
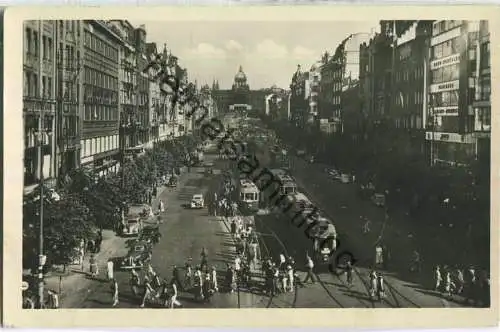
[{"x1": 426, "y1": 20, "x2": 479, "y2": 165}]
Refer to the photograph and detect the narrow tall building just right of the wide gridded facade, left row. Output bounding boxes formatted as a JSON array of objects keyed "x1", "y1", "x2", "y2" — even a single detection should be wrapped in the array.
[{"x1": 108, "y1": 20, "x2": 139, "y2": 151}]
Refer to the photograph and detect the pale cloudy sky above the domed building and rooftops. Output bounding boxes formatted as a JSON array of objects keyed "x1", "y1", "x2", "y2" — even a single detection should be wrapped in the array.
[{"x1": 130, "y1": 21, "x2": 378, "y2": 90}]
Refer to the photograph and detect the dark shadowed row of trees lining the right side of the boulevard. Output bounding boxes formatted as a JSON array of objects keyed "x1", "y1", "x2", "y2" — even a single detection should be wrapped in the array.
[{"x1": 268, "y1": 116, "x2": 490, "y2": 220}]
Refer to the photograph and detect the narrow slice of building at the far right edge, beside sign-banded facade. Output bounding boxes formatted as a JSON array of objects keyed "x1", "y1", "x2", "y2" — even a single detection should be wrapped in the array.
[{"x1": 473, "y1": 21, "x2": 491, "y2": 164}]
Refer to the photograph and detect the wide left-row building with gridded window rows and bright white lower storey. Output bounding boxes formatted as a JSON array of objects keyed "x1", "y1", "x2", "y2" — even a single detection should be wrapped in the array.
[{"x1": 80, "y1": 20, "x2": 122, "y2": 176}]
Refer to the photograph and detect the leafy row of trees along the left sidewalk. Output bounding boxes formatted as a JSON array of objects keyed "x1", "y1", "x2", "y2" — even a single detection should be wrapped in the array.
[{"x1": 23, "y1": 139, "x2": 196, "y2": 268}]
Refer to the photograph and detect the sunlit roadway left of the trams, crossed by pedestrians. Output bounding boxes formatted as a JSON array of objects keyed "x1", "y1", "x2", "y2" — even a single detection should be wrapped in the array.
[{"x1": 66, "y1": 155, "x2": 267, "y2": 308}]
